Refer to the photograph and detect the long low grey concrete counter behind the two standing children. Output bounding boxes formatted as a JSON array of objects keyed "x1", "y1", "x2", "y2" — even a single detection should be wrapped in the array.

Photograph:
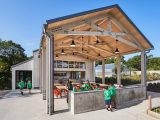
[{"x1": 69, "y1": 86, "x2": 146, "y2": 114}]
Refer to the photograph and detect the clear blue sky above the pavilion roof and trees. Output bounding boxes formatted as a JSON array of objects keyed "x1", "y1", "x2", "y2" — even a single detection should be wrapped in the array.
[{"x1": 0, "y1": 0, "x2": 160, "y2": 58}]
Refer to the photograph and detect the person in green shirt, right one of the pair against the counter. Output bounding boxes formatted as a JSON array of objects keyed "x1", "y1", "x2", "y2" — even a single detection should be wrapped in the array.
[{"x1": 109, "y1": 84, "x2": 117, "y2": 109}]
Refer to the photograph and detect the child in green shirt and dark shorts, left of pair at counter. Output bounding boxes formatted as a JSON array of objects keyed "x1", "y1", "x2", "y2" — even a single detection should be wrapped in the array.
[{"x1": 103, "y1": 88, "x2": 112, "y2": 112}]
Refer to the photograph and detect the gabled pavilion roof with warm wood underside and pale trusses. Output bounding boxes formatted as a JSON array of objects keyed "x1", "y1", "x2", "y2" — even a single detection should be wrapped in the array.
[{"x1": 42, "y1": 5, "x2": 154, "y2": 60}]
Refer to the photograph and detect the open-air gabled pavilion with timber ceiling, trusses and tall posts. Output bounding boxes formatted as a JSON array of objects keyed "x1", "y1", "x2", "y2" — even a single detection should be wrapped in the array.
[{"x1": 40, "y1": 5, "x2": 153, "y2": 114}]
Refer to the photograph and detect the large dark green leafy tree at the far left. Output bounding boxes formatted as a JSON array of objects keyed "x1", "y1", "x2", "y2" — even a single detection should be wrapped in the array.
[{"x1": 0, "y1": 40, "x2": 27, "y2": 89}]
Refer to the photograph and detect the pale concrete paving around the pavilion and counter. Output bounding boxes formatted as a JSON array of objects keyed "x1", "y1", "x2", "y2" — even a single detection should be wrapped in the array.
[{"x1": 0, "y1": 90, "x2": 160, "y2": 120}]
